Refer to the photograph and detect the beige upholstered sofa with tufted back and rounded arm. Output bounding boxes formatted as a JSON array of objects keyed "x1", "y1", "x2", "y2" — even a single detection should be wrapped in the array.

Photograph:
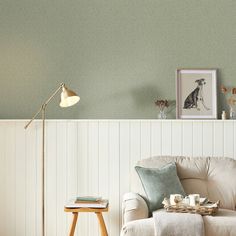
[{"x1": 121, "y1": 156, "x2": 236, "y2": 236}]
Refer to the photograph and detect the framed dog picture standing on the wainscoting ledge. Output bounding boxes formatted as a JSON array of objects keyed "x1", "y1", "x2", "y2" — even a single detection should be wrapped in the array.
[{"x1": 176, "y1": 69, "x2": 217, "y2": 119}]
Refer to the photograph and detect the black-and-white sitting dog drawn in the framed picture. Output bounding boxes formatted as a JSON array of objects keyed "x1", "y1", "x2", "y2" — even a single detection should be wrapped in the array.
[{"x1": 183, "y1": 78, "x2": 210, "y2": 111}]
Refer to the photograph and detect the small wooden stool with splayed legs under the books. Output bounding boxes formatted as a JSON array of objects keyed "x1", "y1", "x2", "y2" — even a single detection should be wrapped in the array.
[{"x1": 64, "y1": 207, "x2": 108, "y2": 236}]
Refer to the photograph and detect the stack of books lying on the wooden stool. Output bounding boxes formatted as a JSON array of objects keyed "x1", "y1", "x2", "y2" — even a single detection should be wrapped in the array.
[{"x1": 66, "y1": 196, "x2": 108, "y2": 209}]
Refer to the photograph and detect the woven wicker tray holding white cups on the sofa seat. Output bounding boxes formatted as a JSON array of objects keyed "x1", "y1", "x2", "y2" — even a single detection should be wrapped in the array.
[{"x1": 163, "y1": 199, "x2": 220, "y2": 216}]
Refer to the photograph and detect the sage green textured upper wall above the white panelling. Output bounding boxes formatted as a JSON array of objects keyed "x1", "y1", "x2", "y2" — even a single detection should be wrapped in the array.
[{"x1": 0, "y1": 0, "x2": 236, "y2": 118}]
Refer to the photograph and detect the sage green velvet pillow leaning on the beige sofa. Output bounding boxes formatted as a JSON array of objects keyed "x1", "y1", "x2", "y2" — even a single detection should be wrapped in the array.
[{"x1": 135, "y1": 162, "x2": 185, "y2": 213}]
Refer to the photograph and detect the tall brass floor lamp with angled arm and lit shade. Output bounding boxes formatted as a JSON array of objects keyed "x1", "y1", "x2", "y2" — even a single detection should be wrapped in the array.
[{"x1": 25, "y1": 83, "x2": 80, "y2": 236}]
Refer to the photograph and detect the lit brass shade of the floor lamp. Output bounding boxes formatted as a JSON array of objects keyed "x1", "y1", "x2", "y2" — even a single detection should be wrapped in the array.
[{"x1": 60, "y1": 86, "x2": 80, "y2": 107}]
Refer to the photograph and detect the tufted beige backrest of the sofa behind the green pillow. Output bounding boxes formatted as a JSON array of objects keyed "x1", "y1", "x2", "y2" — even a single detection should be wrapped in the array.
[{"x1": 133, "y1": 156, "x2": 236, "y2": 210}]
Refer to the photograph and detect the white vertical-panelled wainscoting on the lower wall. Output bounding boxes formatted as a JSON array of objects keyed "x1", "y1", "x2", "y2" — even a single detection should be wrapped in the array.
[{"x1": 0, "y1": 120, "x2": 236, "y2": 236}]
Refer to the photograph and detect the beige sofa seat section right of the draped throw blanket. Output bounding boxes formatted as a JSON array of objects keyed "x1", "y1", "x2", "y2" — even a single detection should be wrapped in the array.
[{"x1": 203, "y1": 209, "x2": 236, "y2": 236}]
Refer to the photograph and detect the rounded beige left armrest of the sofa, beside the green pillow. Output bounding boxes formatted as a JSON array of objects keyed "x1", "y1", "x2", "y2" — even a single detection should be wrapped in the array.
[{"x1": 122, "y1": 193, "x2": 148, "y2": 225}]
